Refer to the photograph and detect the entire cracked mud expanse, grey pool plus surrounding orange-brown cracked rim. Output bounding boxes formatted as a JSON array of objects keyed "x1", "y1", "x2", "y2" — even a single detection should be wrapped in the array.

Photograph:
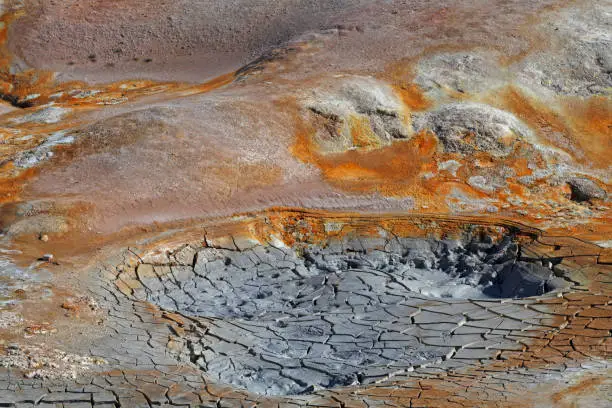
[{"x1": 0, "y1": 213, "x2": 612, "y2": 407}]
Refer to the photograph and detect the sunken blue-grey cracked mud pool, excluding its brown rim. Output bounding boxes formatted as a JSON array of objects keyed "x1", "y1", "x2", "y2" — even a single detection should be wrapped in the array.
[{"x1": 136, "y1": 237, "x2": 567, "y2": 395}]
